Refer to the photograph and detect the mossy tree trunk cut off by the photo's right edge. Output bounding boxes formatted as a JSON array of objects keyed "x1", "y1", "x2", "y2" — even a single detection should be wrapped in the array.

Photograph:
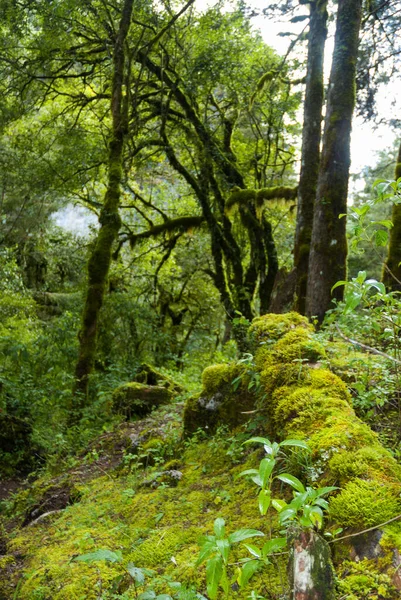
[{"x1": 383, "y1": 144, "x2": 401, "y2": 292}]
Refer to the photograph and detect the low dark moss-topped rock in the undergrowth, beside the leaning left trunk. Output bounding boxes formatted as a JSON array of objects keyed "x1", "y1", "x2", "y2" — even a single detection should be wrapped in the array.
[{"x1": 112, "y1": 383, "x2": 173, "y2": 419}]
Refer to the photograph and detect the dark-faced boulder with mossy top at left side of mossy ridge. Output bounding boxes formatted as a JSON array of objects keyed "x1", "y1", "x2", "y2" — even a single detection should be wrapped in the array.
[{"x1": 184, "y1": 364, "x2": 256, "y2": 436}]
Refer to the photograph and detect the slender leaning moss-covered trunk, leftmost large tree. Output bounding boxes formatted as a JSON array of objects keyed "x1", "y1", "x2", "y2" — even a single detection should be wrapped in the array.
[{"x1": 74, "y1": 0, "x2": 133, "y2": 407}]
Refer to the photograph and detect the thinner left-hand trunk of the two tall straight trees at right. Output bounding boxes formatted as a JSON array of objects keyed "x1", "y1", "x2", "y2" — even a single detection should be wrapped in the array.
[{"x1": 294, "y1": 0, "x2": 327, "y2": 314}]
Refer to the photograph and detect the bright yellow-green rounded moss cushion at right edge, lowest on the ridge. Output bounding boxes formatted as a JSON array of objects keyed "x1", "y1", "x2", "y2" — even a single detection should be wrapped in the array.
[{"x1": 330, "y1": 478, "x2": 401, "y2": 529}]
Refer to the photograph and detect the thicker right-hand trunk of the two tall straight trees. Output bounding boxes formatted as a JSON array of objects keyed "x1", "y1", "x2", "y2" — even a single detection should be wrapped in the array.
[{"x1": 306, "y1": 0, "x2": 362, "y2": 322}]
